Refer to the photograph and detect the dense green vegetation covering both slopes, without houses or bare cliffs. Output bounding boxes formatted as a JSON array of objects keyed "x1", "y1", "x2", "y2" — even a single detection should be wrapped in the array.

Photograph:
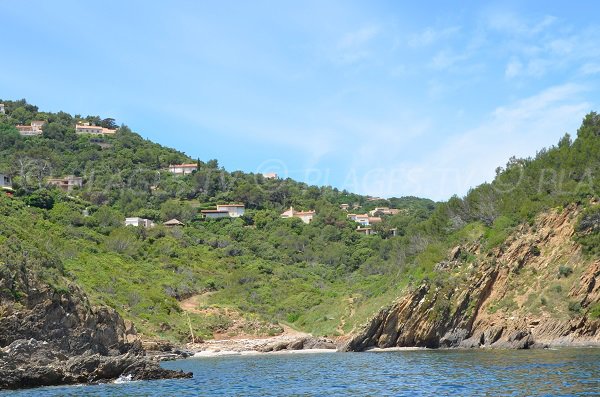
[{"x1": 0, "y1": 97, "x2": 600, "y2": 339}]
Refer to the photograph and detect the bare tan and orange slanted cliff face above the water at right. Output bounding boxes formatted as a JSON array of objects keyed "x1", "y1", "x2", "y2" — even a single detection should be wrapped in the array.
[{"x1": 345, "y1": 207, "x2": 600, "y2": 351}]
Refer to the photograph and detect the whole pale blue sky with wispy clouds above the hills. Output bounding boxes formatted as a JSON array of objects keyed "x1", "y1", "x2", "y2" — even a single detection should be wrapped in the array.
[{"x1": 0, "y1": 0, "x2": 600, "y2": 200}]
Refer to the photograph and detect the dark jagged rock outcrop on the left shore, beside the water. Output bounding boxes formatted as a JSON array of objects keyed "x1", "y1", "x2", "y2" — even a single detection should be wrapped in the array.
[{"x1": 0, "y1": 279, "x2": 192, "y2": 389}]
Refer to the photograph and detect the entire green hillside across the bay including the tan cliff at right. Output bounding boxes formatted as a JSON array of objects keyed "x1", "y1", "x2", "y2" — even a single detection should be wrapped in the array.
[{"x1": 0, "y1": 97, "x2": 600, "y2": 350}]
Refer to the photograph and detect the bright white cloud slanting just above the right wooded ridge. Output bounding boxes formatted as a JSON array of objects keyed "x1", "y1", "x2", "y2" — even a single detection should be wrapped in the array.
[{"x1": 362, "y1": 84, "x2": 590, "y2": 200}]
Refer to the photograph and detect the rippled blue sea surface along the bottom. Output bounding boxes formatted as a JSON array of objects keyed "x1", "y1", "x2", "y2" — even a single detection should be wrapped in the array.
[{"x1": 0, "y1": 348, "x2": 600, "y2": 397}]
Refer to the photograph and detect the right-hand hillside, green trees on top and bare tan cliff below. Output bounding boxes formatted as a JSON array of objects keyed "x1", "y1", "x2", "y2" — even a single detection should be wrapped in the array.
[{"x1": 345, "y1": 113, "x2": 600, "y2": 350}]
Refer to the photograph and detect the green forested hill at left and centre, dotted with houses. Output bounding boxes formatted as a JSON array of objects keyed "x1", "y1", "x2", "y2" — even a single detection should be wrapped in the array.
[{"x1": 0, "y1": 100, "x2": 435, "y2": 339}]
